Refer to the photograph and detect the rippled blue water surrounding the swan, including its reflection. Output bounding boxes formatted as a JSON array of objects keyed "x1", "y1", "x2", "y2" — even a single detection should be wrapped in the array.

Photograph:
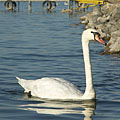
[{"x1": 0, "y1": 2, "x2": 120, "y2": 120}]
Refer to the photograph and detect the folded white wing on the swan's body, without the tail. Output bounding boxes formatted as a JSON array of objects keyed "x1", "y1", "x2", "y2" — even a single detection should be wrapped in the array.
[{"x1": 16, "y1": 78, "x2": 82, "y2": 99}]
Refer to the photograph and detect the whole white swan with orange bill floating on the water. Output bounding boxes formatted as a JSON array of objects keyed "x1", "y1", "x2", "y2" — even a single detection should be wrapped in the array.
[{"x1": 16, "y1": 29, "x2": 105, "y2": 100}]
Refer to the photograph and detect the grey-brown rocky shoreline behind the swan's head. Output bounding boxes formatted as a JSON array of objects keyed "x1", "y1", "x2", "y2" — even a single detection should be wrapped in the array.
[{"x1": 80, "y1": 0, "x2": 120, "y2": 54}]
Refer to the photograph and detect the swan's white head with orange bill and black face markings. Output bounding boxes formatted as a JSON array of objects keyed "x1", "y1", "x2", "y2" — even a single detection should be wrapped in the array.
[{"x1": 82, "y1": 29, "x2": 107, "y2": 46}]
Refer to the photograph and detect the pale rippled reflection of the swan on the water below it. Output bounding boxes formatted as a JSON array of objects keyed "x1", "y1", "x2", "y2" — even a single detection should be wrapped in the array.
[{"x1": 20, "y1": 98, "x2": 96, "y2": 120}]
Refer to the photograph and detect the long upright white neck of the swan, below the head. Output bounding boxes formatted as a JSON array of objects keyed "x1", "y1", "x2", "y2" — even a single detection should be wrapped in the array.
[{"x1": 82, "y1": 37, "x2": 95, "y2": 99}]
